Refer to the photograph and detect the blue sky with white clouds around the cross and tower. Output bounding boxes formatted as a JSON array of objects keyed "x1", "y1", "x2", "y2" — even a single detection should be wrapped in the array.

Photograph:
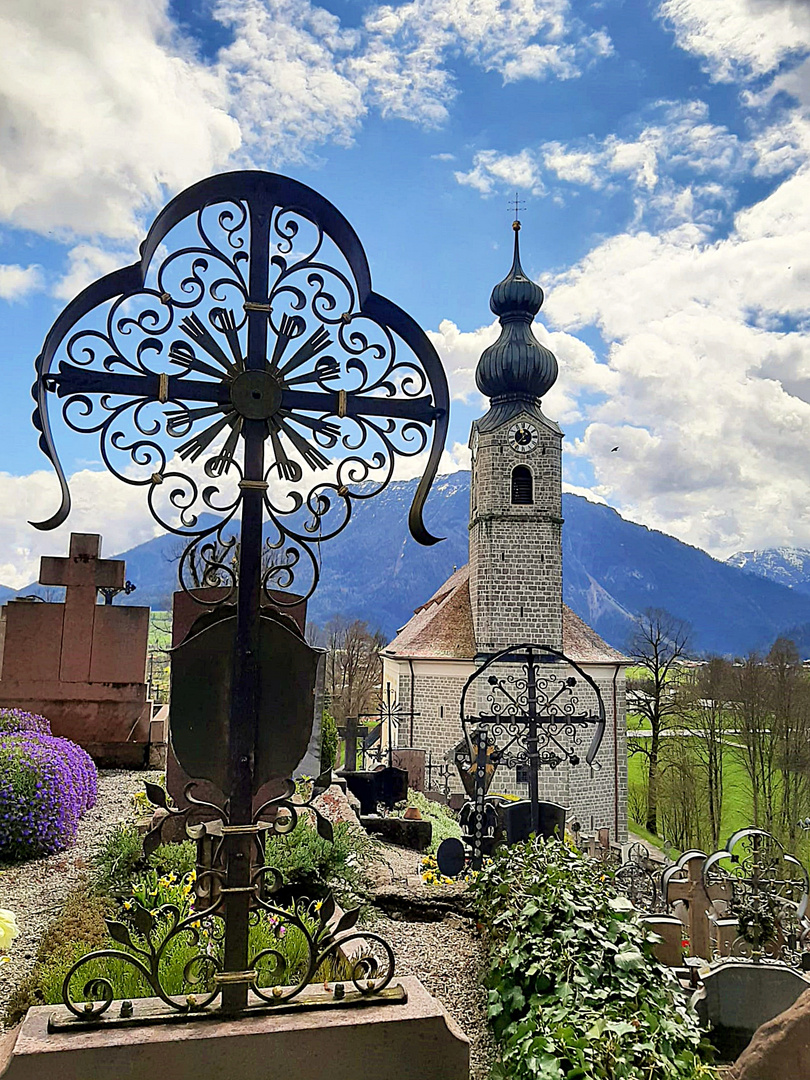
[{"x1": 0, "y1": 0, "x2": 810, "y2": 588}]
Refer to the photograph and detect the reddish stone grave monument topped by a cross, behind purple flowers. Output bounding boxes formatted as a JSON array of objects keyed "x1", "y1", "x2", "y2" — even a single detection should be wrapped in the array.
[{"x1": 0, "y1": 532, "x2": 151, "y2": 767}]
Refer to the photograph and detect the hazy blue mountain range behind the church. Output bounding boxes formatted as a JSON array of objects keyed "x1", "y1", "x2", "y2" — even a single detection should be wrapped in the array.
[{"x1": 6, "y1": 472, "x2": 810, "y2": 656}]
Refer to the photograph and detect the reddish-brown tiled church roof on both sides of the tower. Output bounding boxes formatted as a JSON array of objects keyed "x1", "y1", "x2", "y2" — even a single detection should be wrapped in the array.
[{"x1": 384, "y1": 565, "x2": 627, "y2": 664}]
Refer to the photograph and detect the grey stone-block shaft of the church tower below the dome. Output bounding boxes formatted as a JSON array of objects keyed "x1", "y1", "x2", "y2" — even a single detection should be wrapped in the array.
[{"x1": 470, "y1": 414, "x2": 563, "y2": 652}]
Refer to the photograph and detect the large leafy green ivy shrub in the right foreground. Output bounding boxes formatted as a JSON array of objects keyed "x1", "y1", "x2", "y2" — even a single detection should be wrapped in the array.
[{"x1": 472, "y1": 839, "x2": 713, "y2": 1080}]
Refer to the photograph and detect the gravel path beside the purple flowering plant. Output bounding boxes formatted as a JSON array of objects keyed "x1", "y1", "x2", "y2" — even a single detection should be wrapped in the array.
[{"x1": 0, "y1": 769, "x2": 146, "y2": 1016}]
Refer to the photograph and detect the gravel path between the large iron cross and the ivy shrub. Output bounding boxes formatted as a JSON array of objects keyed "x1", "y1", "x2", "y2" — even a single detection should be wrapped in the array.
[{"x1": 374, "y1": 843, "x2": 495, "y2": 1080}]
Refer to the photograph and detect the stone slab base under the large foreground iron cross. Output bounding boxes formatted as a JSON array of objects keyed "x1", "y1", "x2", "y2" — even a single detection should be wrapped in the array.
[{"x1": 0, "y1": 976, "x2": 470, "y2": 1080}]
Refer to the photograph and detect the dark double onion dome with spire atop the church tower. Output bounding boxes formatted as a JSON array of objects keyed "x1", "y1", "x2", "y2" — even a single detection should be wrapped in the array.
[{"x1": 475, "y1": 221, "x2": 557, "y2": 406}]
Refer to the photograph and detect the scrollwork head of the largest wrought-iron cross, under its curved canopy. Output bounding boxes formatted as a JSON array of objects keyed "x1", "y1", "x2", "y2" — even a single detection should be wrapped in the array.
[{"x1": 32, "y1": 172, "x2": 448, "y2": 595}]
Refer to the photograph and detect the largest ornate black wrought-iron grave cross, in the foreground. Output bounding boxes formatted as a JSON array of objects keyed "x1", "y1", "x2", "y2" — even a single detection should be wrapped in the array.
[{"x1": 33, "y1": 172, "x2": 448, "y2": 1016}]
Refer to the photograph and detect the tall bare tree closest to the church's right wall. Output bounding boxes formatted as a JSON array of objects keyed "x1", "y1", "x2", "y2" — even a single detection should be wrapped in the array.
[{"x1": 627, "y1": 608, "x2": 690, "y2": 834}]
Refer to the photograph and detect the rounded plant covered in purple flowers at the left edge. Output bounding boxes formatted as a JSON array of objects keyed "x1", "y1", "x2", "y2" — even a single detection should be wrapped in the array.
[{"x1": 0, "y1": 708, "x2": 98, "y2": 862}]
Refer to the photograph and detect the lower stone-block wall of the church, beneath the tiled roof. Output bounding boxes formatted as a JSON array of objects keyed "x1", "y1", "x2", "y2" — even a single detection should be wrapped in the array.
[{"x1": 383, "y1": 658, "x2": 627, "y2": 842}]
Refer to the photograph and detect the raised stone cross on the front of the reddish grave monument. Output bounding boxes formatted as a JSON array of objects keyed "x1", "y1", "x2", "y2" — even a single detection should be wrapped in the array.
[{"x1": 39, "y1": 532, "x2": 125, "y2": 683}]
